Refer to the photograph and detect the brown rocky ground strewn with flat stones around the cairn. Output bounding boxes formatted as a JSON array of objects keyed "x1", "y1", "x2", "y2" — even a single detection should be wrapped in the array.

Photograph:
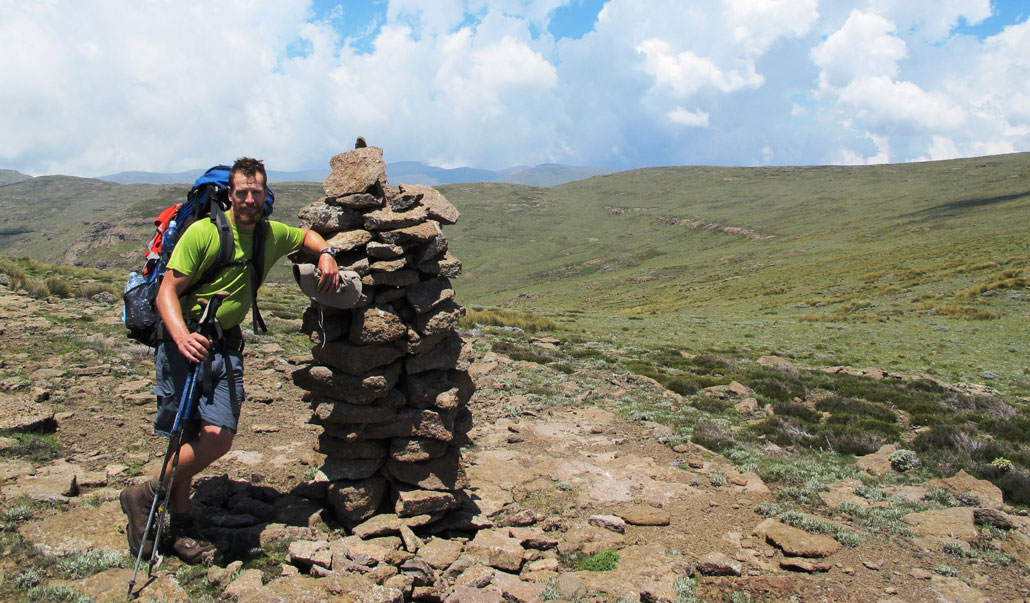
[{"x1": 0, "y1": 287, "x2": 1030, "y2": 602}]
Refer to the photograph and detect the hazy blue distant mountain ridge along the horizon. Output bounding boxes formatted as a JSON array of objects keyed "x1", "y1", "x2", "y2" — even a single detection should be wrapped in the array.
[{"x1": 92, "y1": 161, "x2": 611, "y2": 187}]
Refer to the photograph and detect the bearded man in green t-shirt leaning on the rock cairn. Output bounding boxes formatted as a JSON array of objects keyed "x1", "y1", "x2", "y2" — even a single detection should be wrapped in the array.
[{"x1": 119, "y1": 158, "x2": 340, "y2": 563}]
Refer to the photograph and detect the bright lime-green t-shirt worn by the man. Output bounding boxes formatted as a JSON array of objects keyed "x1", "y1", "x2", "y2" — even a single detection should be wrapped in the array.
[{"x1": 168, "y1": 219, "x2": 304, "y2": 329}]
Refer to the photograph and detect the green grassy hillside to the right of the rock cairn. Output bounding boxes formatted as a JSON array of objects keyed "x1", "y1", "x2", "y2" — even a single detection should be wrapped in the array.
[{"x1": 441, "y1": 154, "x2": 1030, "y2": 395}]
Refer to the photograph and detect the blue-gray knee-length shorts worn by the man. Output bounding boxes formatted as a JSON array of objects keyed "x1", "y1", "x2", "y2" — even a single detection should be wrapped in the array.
[{"x1": 151, "y1": 341, "x2": 246, "y2": 440}]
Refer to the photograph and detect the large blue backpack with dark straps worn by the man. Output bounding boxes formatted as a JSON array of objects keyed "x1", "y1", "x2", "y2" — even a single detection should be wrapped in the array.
[{"x1": 122, "y1": 165, "x2": 275, "y2": 347}]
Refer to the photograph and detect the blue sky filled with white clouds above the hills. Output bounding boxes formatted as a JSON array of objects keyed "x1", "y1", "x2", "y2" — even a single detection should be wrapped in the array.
[{"x1": 0, "y1": 0, "x2": 1030, "y2": 175}]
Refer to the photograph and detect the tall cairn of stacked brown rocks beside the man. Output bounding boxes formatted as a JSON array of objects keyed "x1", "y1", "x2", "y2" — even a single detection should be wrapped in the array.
[{"x1": 293, "y1": 140, "x2": 475, "y2": 533}]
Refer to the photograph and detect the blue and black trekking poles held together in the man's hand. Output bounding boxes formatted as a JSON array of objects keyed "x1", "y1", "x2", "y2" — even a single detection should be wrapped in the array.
[{"x1": 129, "y1": 291, "x2": 229, "y2": 596}]
